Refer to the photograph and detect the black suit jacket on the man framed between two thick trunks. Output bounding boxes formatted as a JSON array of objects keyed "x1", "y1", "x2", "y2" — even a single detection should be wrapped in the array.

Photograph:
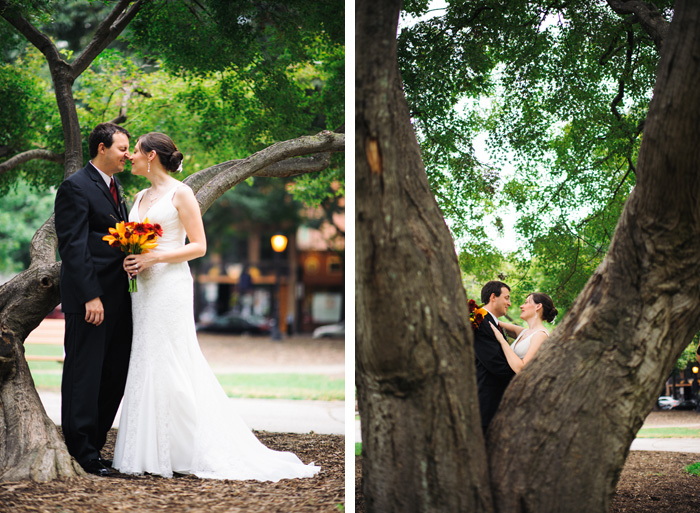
[{"x1": 474, "y1": 313, "x2": 515, "y2": 430}]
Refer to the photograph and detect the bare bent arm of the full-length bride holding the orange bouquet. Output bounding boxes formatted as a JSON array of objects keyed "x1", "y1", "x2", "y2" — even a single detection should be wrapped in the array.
[{"x1": 126, "y1": 187, "x2": 207, "y2": 272}]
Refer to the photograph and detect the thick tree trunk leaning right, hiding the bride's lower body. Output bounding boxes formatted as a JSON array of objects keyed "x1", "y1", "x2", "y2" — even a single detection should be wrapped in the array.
[{"x1": 488, "y1": 0, "x2": 700, "y2": 512}]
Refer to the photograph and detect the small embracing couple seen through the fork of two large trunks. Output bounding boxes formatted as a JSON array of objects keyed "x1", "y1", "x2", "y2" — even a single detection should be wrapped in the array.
[{"x1": 474, "y1": 281, "x2": 557, "y2": 433}]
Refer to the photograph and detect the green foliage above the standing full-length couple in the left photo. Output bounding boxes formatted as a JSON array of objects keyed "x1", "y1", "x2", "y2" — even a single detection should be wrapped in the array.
[{"x1": 0, "y1": 0, "x2": 344, "y2": 206}]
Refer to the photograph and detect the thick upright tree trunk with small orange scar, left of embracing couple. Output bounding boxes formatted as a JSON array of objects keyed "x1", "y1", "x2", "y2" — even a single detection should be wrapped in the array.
[{"x1": 355, "y1": 0, "x2": 492, "y2": 513}]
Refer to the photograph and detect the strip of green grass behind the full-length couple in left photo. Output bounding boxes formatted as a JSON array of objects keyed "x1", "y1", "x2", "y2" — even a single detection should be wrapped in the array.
[{"x1": 26, "y1": 344, "x2": 345, "y2": 401}]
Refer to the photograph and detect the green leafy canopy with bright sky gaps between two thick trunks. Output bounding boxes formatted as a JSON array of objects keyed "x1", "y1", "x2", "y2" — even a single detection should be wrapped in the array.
[{"x1": 399, "y1": 0, "x2": 672, "y2": 309}]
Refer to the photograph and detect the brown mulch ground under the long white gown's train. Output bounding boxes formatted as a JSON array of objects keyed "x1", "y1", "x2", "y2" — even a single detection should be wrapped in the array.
[{"x1": 0, "y1": 429, "x2": 345, "y2": 513}]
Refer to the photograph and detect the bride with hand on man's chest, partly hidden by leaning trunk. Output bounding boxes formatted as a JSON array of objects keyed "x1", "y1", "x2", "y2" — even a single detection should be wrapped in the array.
[{"x1": 491, "y1": 292, "x2": 558, "y2": 373}]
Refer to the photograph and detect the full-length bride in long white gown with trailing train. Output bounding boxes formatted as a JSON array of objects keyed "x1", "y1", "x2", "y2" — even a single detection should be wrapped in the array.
[{"x1": 113, "y1": 132, "x2": 320, "y2": 481}]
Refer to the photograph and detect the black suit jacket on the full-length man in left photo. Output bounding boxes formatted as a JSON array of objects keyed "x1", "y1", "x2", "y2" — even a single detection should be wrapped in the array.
[{"x1": 54, "y1": 163, "x2": 128, "y2": 313}]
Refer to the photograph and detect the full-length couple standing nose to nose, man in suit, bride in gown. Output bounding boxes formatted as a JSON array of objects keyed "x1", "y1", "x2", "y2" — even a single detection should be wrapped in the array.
[{"x1": 55, "y1": 123, "x2": 320, "y2": 481}]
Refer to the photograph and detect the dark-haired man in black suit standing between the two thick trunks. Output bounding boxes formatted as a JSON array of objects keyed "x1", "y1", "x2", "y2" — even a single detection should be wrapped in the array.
[{"x1": 474, "y1": 281, "x2": 515, "y2": 433}]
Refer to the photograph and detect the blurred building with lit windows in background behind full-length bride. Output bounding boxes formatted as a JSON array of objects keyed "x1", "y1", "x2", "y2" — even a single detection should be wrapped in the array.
[{"x1": 193, "y1": 200, "x2": 345, "y2": 334}]
